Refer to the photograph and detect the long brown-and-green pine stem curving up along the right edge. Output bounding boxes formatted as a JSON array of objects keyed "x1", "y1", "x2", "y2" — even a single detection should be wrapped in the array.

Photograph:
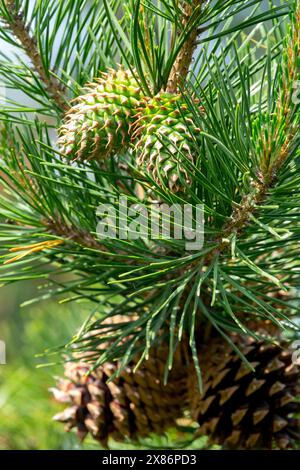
[{"x1": 200, "y1": 1, "x2": 300, "y2": 262}]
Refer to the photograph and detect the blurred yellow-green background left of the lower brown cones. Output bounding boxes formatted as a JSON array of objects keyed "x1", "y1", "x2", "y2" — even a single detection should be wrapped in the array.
[{"x1": 0, "y1": 283, "x2": 89, "y2": 449}]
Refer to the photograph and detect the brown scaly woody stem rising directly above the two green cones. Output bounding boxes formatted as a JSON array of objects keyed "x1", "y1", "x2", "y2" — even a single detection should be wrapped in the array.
[{"x1": 167, "y1": 0, "x2": 206, "y2": 93}]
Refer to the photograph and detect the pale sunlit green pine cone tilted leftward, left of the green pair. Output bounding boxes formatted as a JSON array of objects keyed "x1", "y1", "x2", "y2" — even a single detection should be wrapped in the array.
[{"x1": 58, "y1": 69, "x2": 142, "y2": 160}]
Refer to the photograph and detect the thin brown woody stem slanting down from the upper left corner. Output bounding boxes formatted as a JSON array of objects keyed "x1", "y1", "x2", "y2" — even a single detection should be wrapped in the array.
[{"x1": 5, "y1": 0, "x2": 68, "y2": 111}]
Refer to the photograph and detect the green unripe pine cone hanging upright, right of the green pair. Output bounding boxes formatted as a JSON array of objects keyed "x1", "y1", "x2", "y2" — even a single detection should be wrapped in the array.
[{"x1": 133, "y1": 93, "x2": 200, "y2": 192}]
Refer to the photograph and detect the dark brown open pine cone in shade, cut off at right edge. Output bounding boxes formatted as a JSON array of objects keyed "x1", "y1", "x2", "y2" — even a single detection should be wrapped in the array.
[{"x1": 189, "y1": 336, "x2": 300, "y2": 449}]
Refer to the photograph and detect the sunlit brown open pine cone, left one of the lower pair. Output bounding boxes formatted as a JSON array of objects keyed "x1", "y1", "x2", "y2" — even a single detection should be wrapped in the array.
[{"x1": 52, "y1": 347, "x2": 187, "y2": 445}]
